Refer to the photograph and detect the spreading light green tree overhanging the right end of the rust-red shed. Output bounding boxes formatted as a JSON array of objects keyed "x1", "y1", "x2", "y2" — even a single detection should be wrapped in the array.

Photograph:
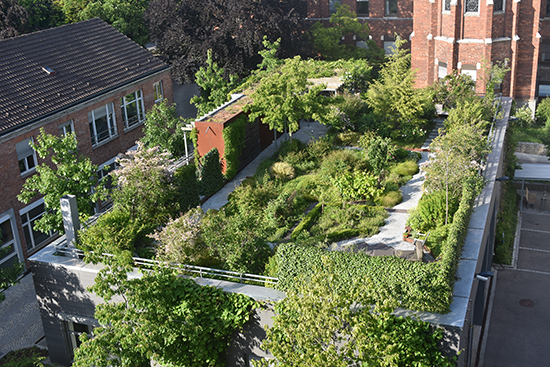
[{"x1": 243, "y1": 56, "x2": 328, "y2": 138}]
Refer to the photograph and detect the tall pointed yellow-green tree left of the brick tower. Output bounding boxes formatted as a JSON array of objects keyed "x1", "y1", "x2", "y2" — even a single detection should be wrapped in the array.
[{"x1": 366, "y1": 37, "x2": 431, "y2": 140}]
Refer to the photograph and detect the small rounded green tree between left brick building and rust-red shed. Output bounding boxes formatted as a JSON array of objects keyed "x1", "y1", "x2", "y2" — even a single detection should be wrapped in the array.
[{"x1": 141, "y1": 100, "x2": 191, "y2": 158}]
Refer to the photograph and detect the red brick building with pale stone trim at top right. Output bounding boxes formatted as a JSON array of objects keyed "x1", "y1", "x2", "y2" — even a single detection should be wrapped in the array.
[{"x1": 308, "y1": 0, "x2": 550, "y2": 107}]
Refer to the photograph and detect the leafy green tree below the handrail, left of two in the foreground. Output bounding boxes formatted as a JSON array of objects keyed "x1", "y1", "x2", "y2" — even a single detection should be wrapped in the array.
[{"x1": 73, "y1": 267, "x2": 255, "y2": 367}]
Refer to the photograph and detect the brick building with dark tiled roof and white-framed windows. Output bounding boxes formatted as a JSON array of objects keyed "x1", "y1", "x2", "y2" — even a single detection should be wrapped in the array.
[{"x1": 0, "y1": 18, "x2": 172, "y2": 267}]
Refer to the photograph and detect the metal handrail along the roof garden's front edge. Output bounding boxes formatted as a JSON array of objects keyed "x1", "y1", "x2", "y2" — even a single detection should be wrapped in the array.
[{"x1": 55, "y1": 243, "x2": 279, "y2": 285}]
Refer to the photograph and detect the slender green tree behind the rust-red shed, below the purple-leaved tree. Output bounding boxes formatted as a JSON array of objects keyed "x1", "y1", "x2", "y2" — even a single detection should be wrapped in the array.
[{"x1": 191, "y1": 50, "x2": 238, "y2": 117}]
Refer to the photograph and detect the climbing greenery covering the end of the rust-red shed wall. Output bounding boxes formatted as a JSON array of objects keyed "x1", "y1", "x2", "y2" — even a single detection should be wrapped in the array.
[{"x1": 222, "y1": 117, "x2": 248, "y2": 180}]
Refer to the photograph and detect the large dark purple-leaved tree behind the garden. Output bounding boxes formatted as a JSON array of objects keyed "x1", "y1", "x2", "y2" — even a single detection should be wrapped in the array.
[{"x1": 145, "y1": 0, "x2": 310, "y2": 83}]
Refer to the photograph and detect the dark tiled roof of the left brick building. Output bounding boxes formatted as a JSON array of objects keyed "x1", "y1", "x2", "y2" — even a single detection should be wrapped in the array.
[{"x1": 0, "y1": 18, "x2": 168, "y2": 135}]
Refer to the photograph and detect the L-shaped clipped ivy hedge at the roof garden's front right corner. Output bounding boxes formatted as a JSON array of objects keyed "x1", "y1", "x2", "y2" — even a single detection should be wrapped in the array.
[{"x1": 275, "y1": 177, "x2": 486, "y2": 313}]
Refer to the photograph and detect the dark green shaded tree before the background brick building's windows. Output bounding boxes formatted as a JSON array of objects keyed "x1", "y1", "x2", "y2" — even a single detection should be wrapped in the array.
[{"x1": 311, "y1": 4, "x2": 384, "y2": 61}]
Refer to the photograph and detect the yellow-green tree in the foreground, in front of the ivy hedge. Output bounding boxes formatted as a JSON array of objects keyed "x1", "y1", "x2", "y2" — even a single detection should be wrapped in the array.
[{"x1": 259, "y1": 259, "x2": 454, "y2": 367}]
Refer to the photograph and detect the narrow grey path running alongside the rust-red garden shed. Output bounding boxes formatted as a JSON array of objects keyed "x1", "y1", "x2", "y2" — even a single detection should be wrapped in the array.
[{"x1": 201, "y1": 120, "x2": 328, "y2": 211}]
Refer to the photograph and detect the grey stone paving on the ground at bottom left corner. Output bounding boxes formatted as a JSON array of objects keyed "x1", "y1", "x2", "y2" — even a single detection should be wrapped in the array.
[{"x1": 0, "y1": 274, "x2": 44, "y2": 358}]
